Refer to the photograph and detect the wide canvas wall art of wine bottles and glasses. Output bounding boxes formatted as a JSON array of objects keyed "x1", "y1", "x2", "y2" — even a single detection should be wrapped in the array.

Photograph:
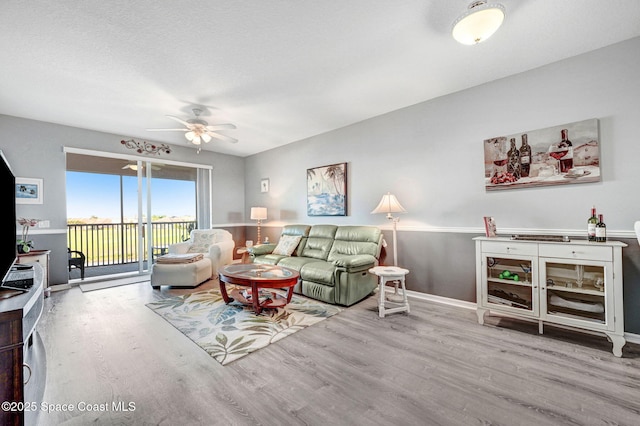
[{"x1": 484, "y1": 119, "x2": 600, "y2": 191}]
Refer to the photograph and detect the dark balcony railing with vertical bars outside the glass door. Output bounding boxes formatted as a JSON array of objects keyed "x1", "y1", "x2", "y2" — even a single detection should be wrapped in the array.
[{"x1": 67, "y1": 221, "x2": 196, "y2": 267}]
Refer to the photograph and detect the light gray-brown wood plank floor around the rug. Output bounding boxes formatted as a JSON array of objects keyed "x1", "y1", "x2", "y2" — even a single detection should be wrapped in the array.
[{"x1": 38, "y1": 282, "x2": 640, "y2": 426}]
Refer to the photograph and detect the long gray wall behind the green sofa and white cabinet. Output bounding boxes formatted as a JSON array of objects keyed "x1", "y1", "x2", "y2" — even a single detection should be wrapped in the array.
[{"x1": 245, "y1": 38, "x2": 640, "y2": 334}]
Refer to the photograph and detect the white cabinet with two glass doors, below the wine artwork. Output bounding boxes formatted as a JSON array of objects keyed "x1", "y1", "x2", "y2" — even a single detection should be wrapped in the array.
[{"x1": 474, "y1": 237, "x2": 626, "y2": 357}]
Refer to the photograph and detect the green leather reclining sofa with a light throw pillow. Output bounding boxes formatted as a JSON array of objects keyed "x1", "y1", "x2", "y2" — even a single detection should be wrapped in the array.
[{"x1": 249, "y1": 225, "x2": 383, "y2": 306}]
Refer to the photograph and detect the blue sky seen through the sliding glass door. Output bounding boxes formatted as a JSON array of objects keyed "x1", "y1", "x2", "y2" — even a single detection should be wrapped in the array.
[{"x1": 67, "y1": 172, "x2": 196, "y2": 221}]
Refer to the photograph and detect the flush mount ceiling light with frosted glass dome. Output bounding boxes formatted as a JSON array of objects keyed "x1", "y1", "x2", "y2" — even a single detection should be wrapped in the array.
[{"x1": 451, "y1": 0, "x2": 505, "y2": 45}]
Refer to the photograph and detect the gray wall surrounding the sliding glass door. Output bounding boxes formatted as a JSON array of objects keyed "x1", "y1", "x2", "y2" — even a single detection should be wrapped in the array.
[{"x1": 0, "y1": 115, "x2": 244, "y2": 284}]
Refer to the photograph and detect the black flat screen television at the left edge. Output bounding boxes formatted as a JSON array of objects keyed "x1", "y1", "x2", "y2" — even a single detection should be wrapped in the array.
[{"x1": 0, "y1": 150, "x2": 18, "y2": 282}]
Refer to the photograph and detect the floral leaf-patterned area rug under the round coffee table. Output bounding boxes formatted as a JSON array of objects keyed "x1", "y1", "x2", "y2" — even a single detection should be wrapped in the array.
[{"x1": 146, "y1": 289, "x2": 342, "y2": 365}]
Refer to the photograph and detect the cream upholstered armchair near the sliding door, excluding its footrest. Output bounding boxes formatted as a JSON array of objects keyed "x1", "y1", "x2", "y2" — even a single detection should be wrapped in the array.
[{"x1": 169, "y1": 229, "x2": 236, "y2": 279}]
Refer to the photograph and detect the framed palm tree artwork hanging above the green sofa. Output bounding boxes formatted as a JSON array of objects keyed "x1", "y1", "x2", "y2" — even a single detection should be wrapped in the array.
[{"x1": 307, "y1": 163, "x2": 347, "y2": 216}]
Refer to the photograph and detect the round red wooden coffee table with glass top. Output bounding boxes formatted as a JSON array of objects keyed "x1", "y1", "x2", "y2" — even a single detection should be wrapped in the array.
[{"x1": 218, "y1": 263, "x2": 300, "y2": 314}]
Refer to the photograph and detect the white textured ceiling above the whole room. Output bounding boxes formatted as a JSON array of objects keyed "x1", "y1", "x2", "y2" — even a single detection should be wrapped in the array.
[{"x1": 0, "y1": 0, "x2": 640, "y2": 156}]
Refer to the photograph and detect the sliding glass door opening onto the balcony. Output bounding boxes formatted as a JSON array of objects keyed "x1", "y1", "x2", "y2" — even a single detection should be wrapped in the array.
[{"x1": 67, "y1": 150, "x2": 208, "y2": 280}]
